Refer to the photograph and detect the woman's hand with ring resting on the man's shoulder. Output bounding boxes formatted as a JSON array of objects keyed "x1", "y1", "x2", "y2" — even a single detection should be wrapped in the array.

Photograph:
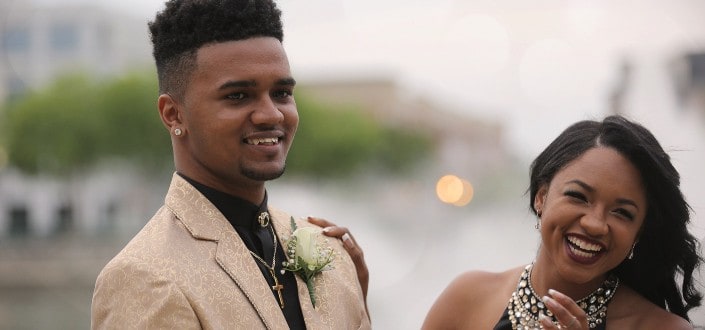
[{"x1": 307, "y1": 217, "x2": 370, "y2": 317}]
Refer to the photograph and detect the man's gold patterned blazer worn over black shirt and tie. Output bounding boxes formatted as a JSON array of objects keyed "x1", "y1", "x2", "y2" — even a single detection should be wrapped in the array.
[{"x1": 91, "y1": 174, "x2": 370, "y2": 330}]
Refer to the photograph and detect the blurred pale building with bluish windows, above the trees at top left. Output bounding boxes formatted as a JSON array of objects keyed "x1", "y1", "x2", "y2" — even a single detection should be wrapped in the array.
[{"x1": 0, "y1": 1, "x2": 151, "y2": 101}]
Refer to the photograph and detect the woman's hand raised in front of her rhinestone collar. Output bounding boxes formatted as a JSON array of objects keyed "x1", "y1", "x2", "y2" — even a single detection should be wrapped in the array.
[{"x1": 539, "y1": 289, "x2": 588, "y2": 329}]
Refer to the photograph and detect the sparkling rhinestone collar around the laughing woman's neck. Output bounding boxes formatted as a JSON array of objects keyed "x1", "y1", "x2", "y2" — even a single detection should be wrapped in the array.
[{"x1": 508, "y1": 264, "x2": 619, "y2": 330}]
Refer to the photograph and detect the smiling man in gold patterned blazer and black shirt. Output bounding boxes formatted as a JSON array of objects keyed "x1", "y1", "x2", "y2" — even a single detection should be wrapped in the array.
[{"x1": 92, "y1": 0, "x2": 370, "y2": 329}]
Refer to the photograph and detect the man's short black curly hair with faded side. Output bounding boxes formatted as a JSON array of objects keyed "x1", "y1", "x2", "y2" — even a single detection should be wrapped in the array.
[{"x1": 149, "y1": 0, "x2": 284, "y2": 98}]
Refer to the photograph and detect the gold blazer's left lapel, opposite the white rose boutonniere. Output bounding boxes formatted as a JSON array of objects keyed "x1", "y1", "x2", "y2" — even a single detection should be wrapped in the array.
[{"x1": 166, "y1": 173, "x2": 288, "y2": 329}]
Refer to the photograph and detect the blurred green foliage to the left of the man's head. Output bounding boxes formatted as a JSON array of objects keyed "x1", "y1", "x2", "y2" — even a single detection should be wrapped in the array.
[{"x1": 2, "y1": 72, "x2": 171, "y2": 175}]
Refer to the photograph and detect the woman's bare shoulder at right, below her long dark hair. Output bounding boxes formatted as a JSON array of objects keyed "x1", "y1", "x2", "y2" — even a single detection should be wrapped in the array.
[{"x1": 607, "y1": 285, "x2": 693, "y2": 329}]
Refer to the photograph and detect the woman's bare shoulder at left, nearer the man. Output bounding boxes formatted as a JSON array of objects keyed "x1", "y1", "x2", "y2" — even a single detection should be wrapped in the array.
[{"x1": 423, "y1": 267, "x2": 524, "y2": 329}]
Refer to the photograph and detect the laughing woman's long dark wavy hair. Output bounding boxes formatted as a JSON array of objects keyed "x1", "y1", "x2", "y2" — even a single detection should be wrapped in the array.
[{"x1": 529, "y1": 116, "x2": 703, "y2": 320}]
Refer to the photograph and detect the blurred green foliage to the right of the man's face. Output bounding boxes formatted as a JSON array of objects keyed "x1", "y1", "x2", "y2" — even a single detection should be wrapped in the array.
[{"x1": 287, "y1": 94, "x2": 431, "y2": 177}]
